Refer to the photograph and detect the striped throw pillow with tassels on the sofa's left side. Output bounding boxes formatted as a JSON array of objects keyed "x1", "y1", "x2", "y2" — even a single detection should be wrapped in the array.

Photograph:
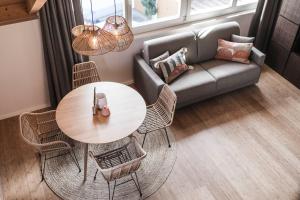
[{"x1": 155, "y1": 48, "x2": 189, "y2": 83}]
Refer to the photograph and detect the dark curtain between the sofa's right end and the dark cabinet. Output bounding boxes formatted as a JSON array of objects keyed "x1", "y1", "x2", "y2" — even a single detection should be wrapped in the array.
[{"x1": 248, "y1": 0, "x2": 282, "y2": 52}]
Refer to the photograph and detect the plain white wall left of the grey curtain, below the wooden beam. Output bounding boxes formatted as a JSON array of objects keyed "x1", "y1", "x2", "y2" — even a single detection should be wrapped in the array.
[{"x1": 0, "y1": 20, "x2": 49, "y2": 119}]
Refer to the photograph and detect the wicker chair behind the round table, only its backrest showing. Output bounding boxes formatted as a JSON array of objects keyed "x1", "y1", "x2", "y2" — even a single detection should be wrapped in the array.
[{"x1": 72, "y1": 61, "x2": 101, "y2": 89}]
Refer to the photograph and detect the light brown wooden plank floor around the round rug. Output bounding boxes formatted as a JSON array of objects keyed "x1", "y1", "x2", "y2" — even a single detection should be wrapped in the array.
[{"x1": 0, "y1": 67, "x2": 300, "y2": 200}]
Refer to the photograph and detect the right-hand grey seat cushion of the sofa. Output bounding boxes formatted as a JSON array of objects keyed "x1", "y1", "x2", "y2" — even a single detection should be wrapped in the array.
[{"x1": 200, "y1": 60, "x2": 261, "y2": 93}]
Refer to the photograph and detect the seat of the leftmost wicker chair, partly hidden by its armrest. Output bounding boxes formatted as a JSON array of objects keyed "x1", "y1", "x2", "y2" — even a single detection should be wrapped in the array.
[{"x1": 39, "y1": 130, "x2": 74, "y2": 151}]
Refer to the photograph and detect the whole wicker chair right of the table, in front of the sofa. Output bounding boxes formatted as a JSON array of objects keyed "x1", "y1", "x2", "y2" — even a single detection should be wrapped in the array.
[{"x1": 137, "y1": 85, "x2": 177, "y2": 147}]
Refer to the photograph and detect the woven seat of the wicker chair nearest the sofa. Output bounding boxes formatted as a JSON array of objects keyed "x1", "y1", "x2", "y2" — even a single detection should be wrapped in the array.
[{"x1": 138, "y1": 107, "x2": 167, "y2": 134}]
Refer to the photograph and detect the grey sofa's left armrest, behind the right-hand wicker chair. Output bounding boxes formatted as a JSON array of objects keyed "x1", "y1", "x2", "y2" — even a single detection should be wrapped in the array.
[{"x1": 133, "y1": 55, "x2": 165, "y2": 104}]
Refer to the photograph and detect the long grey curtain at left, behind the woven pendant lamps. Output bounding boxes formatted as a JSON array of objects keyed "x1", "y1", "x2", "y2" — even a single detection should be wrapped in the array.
[{"x1": 40, "y1": 0, "x2": 83, "y2": 108}]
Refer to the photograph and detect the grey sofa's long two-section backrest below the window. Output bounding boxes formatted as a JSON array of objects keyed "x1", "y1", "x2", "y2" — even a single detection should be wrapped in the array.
[{"x1": 143, "y1": 22, "x2": 240, "y2": 64}]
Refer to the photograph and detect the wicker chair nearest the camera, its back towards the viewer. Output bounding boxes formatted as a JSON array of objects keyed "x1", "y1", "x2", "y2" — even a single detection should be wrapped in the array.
[{"x1": 89, "y1": 136, "x2": 146, "y2": 199}]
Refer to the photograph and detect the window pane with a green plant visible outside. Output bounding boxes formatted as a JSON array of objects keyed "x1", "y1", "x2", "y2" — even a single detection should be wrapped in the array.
[{"x1": 132, "y1": 0, "x2": 181, "y2": 26}]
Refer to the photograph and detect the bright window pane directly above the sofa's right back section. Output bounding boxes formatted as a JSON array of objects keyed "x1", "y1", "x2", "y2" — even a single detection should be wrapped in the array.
[{"x1": 191, "y1": 0, "x2": 232, "y2": 15}]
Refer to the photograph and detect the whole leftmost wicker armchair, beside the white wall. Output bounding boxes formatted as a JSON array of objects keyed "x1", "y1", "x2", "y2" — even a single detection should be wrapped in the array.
[{"x1": 19, "y1": 111, "x2": 81, "y2": 181}]
